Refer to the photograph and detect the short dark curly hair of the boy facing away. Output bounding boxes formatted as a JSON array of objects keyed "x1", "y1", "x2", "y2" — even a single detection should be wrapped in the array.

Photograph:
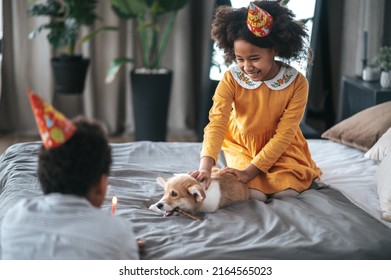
[{"x1": 38, "y1": 117, "x2": 112, "y2": 196}]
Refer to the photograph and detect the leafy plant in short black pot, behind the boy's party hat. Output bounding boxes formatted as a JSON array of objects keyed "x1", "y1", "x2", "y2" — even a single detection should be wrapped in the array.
[{"x1": 27, "y1": 0, "x2": 98, "y2": 93}]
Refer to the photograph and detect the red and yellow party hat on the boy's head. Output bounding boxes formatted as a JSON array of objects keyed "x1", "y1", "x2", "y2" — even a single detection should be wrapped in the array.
[{"x1": 28, "y1": 89, "x2": 76, "y2": 150}]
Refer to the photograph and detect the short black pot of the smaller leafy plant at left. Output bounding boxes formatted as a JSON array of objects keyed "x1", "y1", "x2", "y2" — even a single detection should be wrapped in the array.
[{"x1": 51, "y1": 55, "x2": 89, "y2": 94}]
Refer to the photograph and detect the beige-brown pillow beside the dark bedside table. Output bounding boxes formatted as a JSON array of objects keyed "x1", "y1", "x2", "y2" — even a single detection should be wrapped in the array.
[{"x1": 321, "y1": 101, "x2": 391, "y2": 152}]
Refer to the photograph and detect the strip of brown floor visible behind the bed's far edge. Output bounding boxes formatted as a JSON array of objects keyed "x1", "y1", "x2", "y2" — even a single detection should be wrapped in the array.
[{"x1": 0, "y1": 132, "x2": 198, "y2": 154}]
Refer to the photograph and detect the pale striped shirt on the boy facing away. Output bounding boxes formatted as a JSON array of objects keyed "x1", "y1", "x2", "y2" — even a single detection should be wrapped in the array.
[{"x1": 0, "y1": 193, "x2": 139, "y2": 260}]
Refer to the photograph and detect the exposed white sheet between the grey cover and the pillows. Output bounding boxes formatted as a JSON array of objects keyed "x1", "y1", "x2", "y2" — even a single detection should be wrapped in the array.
[{"x1": 308, "y1": 139, "x2": 391, "y2": 228}]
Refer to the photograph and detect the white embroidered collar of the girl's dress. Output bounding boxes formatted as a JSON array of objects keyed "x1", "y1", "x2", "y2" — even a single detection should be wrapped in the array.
[{"x1": 229, "y1": 64, "x2": 298, "y2": 90}]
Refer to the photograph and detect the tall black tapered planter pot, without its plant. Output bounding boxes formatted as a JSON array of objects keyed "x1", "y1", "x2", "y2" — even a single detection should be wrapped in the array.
[{"x1": 130, "y1": 69, "x2": 172, "y2": 141}]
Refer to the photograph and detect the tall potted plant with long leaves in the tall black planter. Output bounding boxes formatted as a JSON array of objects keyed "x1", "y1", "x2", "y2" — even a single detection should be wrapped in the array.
[{"x1": 106, "y1": 0, "x2": 189, "y2": 141}]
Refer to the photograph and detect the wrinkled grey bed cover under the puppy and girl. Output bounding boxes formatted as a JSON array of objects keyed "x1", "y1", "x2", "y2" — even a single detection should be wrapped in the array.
[{"x1": 0, "y1": 141, "x2": 391, "y2": 260}]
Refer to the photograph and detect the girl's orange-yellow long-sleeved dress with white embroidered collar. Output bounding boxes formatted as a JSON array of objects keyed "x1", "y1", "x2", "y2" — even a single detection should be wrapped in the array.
[{"x1": 201, "y1": 64, "x2": 321, "y2": 194}]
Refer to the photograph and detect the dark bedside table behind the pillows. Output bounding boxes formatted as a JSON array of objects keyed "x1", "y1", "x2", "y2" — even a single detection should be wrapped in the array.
[{"x1": 337, "y1": 76, "x2": 391, "y2": 122}]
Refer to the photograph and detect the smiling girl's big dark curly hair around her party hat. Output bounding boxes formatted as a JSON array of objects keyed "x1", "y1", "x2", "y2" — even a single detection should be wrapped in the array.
[{"x1": 211, "y1": 1, "x2": 308, "y2": 64}]
